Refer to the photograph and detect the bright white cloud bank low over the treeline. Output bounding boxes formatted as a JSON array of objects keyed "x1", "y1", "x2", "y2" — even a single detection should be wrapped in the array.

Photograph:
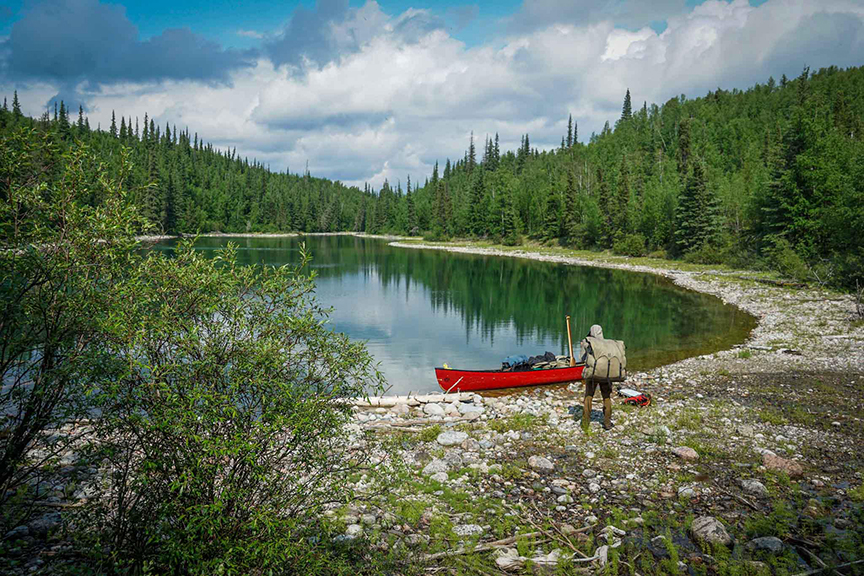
[{"x1": 4, "y1": 0, "x2": 864, "y2": 187}]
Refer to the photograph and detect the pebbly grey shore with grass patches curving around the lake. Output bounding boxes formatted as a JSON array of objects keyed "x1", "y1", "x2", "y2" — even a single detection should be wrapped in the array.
[{"x1": 328, "y1": 243, "x2": 864, "y2": 574}]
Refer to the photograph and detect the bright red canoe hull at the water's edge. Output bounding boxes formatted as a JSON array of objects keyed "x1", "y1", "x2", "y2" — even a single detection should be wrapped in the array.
[{"x1": 435, "y1": 364, "x2": 585, "y2": 392}]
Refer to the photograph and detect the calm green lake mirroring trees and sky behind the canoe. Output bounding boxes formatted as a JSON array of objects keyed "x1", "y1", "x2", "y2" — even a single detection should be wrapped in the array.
[{"x1": 155, "y1": 236, "x2": 755, "y2": 394}]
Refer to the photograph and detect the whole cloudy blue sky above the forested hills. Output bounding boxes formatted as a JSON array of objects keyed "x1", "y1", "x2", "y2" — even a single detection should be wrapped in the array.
[{"x1": 0, "y1": 0, "x2": 864, "y2": 188}]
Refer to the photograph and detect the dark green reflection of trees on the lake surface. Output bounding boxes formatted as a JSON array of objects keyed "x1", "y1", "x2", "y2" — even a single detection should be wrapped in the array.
[{"x1": 174, "y1": 236, "x2": 752, "y2": 365}]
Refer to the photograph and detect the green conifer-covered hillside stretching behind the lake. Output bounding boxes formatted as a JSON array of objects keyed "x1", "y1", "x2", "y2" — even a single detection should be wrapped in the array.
[{"x1": 0, "y1": 67, "x2": 864, "y2": 287}]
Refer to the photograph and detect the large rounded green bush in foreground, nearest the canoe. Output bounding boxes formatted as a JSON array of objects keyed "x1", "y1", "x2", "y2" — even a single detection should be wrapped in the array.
[{"x1": 82, "y1": 242, "x2": 383, "y2": 574}]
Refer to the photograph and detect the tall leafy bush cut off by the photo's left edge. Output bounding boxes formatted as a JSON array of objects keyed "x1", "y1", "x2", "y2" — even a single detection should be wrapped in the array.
[{"x1": 0, "y1": 130, "x2": 140, "y2": 533}]
